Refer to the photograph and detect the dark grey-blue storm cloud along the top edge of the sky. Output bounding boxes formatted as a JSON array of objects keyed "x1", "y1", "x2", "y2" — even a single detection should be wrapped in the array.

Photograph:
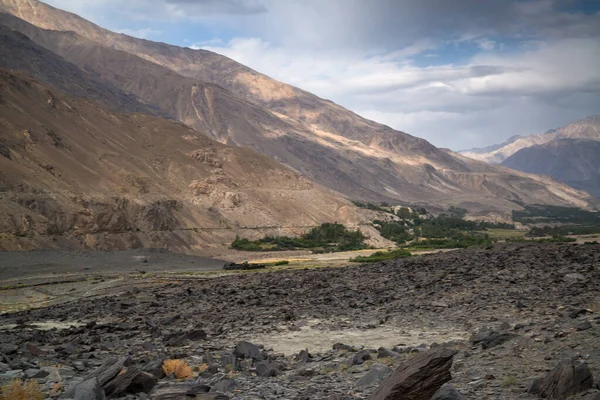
[{"x1": 259, "y1": 0, "x2": 600, "y2": 48}]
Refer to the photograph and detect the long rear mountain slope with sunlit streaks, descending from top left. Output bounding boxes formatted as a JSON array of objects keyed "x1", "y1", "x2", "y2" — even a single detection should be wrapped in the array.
[{"x1": 0, "y1": 0, "x2": 594, "y2": 214}]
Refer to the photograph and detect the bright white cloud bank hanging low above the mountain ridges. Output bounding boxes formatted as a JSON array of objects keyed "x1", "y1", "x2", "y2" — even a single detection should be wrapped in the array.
[{"x1": 205, "y1": 38, "x2": 600, "y2": 149}]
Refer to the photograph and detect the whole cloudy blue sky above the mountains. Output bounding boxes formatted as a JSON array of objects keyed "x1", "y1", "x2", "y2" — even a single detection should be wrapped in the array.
[{"x1": 46, "y1": 0, "x2": 600, "y2": 150}]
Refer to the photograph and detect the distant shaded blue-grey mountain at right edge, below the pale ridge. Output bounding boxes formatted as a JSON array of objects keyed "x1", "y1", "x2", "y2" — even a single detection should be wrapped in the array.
[{"x1": 502, "y1": 139, "x2": 600, "y2": 199}]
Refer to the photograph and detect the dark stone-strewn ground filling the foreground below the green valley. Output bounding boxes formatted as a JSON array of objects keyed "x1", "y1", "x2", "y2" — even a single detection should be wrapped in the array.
[{"x1": 0, "y1": 243, "x2": 600, "y2": 400}]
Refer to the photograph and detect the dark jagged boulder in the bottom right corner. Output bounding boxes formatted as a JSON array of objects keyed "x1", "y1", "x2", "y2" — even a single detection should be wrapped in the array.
[{"x1": 529, "y1": 358, "x2": 594, "y2": 400}]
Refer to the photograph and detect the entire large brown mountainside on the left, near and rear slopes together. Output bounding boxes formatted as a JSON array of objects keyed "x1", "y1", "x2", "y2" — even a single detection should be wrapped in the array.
[{"x1": 0, "y1": 0, "x2": 597, "y2": 247}]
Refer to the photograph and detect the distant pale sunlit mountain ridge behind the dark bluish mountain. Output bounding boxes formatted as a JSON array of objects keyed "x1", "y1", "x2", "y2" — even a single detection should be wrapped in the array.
[{"x1": 461, "y1": 116, "x2": 600, "y2": 164}]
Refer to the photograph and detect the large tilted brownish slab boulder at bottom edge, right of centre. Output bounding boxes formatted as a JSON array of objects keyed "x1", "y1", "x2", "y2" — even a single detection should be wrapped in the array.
[{"x1": 369, "y1": 347, "x2": 456, "y2": 400}]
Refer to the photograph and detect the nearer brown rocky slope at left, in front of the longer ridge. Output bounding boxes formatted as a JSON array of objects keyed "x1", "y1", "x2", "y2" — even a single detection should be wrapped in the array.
[{"x1": 0, "y1": 69, "x2": 370, "y2": 253}]
